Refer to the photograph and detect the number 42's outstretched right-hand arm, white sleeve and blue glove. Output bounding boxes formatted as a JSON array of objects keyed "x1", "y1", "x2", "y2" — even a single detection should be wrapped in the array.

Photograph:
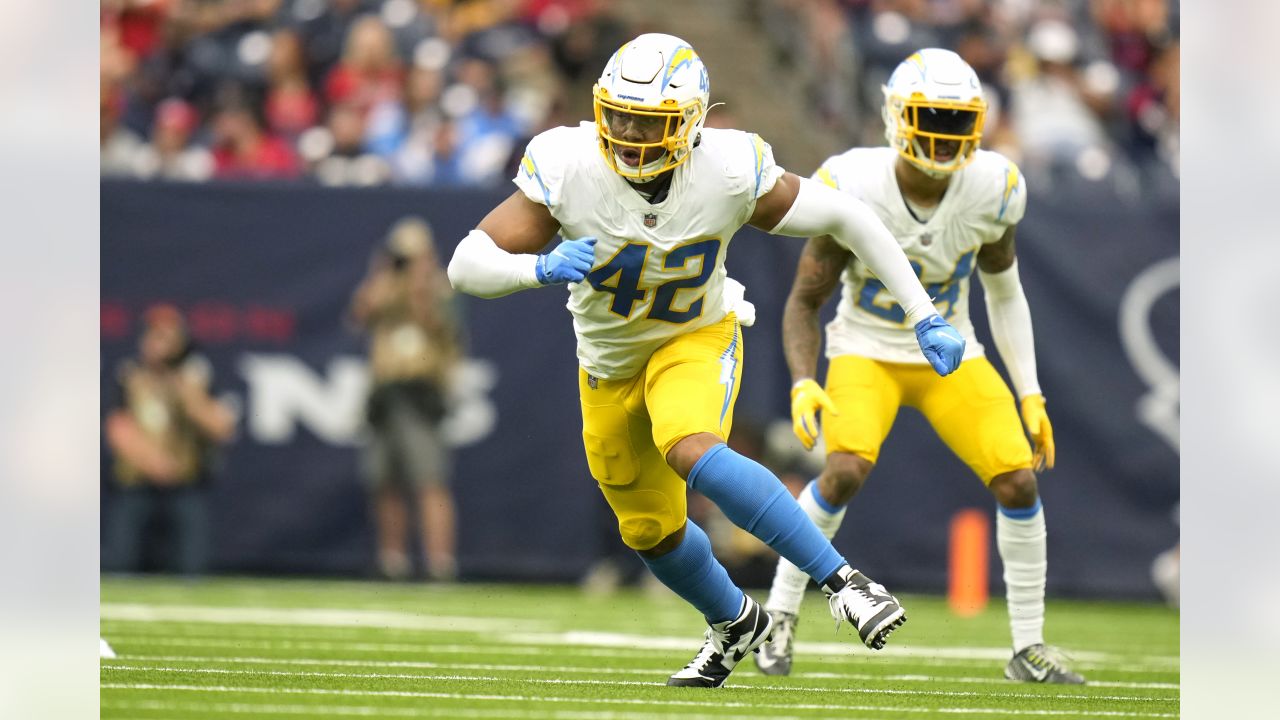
[{"x1": 748, "y1": 173, "x2": 964, "y2": 375}]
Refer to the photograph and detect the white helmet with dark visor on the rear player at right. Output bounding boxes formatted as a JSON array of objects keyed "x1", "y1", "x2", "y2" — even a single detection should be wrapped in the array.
[{"x1": 882, "y1": 47, "x2": 987, "y2": 177}]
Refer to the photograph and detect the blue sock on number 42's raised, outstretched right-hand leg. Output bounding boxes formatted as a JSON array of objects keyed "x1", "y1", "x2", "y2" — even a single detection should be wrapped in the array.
[{"x1": 689, "y1": 443, "x2": 845, "y2": 584}]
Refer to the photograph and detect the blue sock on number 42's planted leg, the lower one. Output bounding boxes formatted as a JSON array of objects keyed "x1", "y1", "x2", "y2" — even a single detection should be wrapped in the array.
[{"x1": 640, "y1": 520, "x2": 742, "y2": 624}]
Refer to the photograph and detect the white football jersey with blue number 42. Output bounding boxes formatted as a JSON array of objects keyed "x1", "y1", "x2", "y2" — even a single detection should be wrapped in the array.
[{"x1": 515, "y1": 122, "x2": 783, "y2": 379}]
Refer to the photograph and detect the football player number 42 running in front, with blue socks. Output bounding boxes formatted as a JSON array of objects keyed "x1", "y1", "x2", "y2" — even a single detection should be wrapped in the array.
[{"x1": 449, "y1": 35, "x2": 964, "y2": 687}]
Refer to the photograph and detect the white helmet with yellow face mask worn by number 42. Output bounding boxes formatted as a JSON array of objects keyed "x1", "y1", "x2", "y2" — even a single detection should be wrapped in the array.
[{"x1": 593, "y1": 33, "x2": 710, "y2": 182}]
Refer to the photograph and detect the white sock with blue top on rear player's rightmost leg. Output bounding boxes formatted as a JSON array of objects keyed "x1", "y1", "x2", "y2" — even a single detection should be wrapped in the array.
[{"x1": 996, "y1": 498, "x2": 1048, "y2": 652}]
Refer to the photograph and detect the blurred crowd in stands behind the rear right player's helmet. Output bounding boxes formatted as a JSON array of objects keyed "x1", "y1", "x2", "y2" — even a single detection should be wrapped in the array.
[{"x1": 759, "y1": 0, "x2": 1179, "y2": 179}]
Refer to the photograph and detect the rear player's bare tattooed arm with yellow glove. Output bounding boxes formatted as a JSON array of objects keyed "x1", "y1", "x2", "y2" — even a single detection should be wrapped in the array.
[{"x1": 782, "y1": 236, "x2": 849, "y2": 450}]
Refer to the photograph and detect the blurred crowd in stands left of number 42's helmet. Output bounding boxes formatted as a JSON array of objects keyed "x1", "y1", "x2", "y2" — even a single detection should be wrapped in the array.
[{"x1": 100, "y1": 0, "x2": 627, "y2": 186}]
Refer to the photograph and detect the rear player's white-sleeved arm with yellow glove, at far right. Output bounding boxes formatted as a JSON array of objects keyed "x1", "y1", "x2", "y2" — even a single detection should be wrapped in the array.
[{"x1": 978, "y1": 225, "x2": 1055, "y2": 469}]
